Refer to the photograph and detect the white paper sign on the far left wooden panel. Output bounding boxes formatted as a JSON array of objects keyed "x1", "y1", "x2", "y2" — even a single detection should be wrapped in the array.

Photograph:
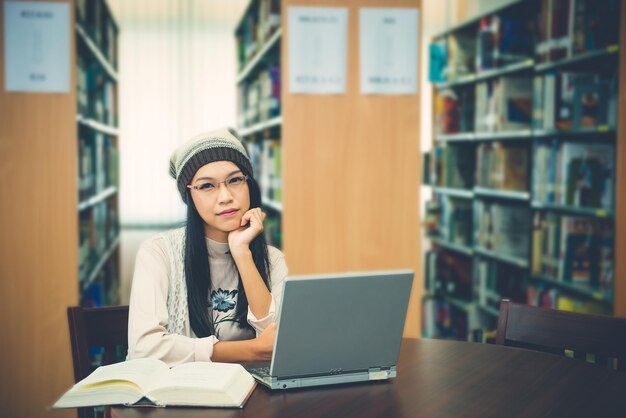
[{"x1": 3, "y1": 1, "x2": 71, "y2": 93}]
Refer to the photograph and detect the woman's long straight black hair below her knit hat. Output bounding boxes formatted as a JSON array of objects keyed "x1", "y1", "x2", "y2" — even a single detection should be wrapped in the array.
[{"x1": 184, "y1": 165, "x2": 270, "y2": 337}]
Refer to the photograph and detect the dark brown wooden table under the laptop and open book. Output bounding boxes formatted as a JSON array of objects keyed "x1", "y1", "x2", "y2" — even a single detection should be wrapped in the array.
[{"x1": 112, "y1": 339, "x2": 626, "y2": 418}]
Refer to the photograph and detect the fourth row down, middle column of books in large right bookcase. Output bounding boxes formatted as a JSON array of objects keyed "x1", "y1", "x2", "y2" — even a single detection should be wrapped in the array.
[{"x1": 474, "y1": 200, "x2": 531, "y2": 259}]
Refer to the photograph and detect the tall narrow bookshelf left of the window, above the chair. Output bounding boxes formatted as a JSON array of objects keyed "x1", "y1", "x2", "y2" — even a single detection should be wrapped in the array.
[{"x1": 74, "y1": 0, "x2": 120, "y2": 306}]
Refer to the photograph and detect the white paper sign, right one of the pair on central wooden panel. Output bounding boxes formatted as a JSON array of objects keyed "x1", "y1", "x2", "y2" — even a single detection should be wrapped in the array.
[{"x1": 359, "y1": 8, "x2": 418, "y2": 94}]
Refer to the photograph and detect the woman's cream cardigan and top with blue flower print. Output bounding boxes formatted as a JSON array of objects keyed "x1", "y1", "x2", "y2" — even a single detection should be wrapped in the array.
[{"x1": 128, "y1": 228, "x2": 287, "y2": 367}]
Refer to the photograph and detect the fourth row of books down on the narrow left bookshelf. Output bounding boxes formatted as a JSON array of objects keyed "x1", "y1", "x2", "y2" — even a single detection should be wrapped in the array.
[{"x1": 78, "y1": 200, "x2": 120, "y2": 283}]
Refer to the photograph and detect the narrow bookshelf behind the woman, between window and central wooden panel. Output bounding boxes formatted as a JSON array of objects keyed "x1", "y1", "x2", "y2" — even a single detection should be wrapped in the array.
[{"x1": 235, "y1": 0, "x2": 283, "y2": 248}]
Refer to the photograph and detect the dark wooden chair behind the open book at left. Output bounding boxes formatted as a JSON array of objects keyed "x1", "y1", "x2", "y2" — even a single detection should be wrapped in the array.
[{"x1": 67, "y1": 306, "x2": 128, "y2": 418}]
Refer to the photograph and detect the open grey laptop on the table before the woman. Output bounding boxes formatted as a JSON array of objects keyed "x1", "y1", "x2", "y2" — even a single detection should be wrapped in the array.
[{"x1": 248, "y1": 270, "x2": 413, "y2": 389}]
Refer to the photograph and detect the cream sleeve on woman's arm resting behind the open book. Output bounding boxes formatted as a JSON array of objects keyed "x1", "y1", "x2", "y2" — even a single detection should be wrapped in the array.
[{"x1": 128, "y1": 238, "x2": 218, "y2": 367}]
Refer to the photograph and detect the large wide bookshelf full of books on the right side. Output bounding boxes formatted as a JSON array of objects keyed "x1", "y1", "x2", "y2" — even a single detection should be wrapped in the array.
[{"x1": 422, "y1": 0, "x2": 626, "y2": 340}]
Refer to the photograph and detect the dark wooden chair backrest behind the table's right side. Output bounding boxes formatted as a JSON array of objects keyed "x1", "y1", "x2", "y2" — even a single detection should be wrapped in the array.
[{"x1": 496, "y1": 299, "x2": 626, "y2": 371}]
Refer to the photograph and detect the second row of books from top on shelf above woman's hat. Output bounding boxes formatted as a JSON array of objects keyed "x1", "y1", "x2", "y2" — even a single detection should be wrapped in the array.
[{"x1": 237, "y1": 64, "x2": 281, "y2": 126}]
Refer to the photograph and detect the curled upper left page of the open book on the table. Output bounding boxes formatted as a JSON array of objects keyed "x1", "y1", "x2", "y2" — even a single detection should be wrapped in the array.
[{"x1": 80, "y1": 358, "x2": 169, "y2": 392}]
